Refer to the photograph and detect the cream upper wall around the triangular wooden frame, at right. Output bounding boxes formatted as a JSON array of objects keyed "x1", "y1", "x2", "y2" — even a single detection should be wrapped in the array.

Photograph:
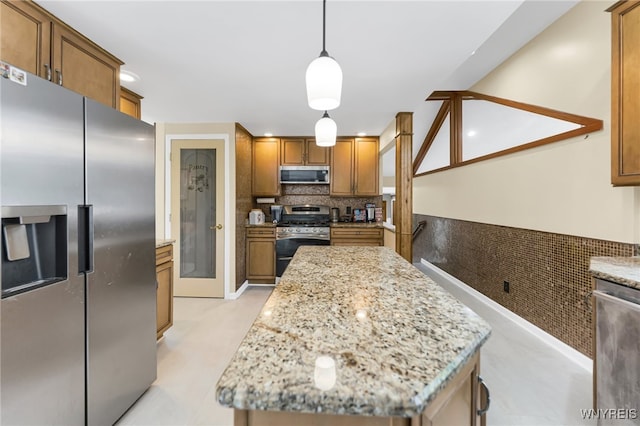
[{"x1": 413, "y1": 1, "x2": 640, "y2": 243}]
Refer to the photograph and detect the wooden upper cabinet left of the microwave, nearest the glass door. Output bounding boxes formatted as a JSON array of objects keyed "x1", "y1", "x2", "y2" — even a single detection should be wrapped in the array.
[{"x1": 251, "y1": 138, "x2": 280, "y2": 196}]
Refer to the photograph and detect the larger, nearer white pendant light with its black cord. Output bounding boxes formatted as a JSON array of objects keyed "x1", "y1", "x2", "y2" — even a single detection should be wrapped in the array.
[{"x1": 305, "y1": 0, "x2": 342, "y2": 111}]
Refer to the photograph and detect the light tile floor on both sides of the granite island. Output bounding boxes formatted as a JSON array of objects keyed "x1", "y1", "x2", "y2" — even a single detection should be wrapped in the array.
[{"x1": 117, "y1": 270, "x2": 595, "y2": 426}]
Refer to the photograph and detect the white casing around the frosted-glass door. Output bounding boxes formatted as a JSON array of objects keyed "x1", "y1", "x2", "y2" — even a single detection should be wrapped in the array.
[{"x1": 164, "y1": 133, "x2": 235, "y2": 299}]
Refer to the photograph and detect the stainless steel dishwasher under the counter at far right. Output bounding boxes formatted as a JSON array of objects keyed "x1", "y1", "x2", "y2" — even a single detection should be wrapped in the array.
[{"x1": 593, "y1": 279, "x2": 640, "y2": 426}]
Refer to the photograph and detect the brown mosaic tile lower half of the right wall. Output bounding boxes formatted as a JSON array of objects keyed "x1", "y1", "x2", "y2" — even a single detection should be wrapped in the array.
[{"x1": 413, "y1": 215, "x2": 640, "y2": 357}]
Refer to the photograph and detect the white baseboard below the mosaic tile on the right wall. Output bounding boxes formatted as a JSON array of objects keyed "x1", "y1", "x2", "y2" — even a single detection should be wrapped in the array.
[{"x1": 420, "y1": 259, "x2": 593, "y2": 372}]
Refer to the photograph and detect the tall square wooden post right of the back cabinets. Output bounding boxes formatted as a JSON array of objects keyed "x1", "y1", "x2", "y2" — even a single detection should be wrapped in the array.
[{"x1": 394, "y1": 112, "x2": 413, "y2": 262}]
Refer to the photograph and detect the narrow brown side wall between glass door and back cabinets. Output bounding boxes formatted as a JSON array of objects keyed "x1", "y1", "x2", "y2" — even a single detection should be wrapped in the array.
[{"x1": 236, "y1": 125, "x2": 253, "y2": 290}]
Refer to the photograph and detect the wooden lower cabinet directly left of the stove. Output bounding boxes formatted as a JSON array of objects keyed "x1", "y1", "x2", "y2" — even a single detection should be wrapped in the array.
[{"x1": 246, "y1": 227, "x2": 276, "y2": 284}]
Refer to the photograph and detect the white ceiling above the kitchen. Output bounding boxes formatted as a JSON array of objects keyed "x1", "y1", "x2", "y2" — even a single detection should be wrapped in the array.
[{"x1": 37, "y1": 0, "x2": 577, "y2": 145}]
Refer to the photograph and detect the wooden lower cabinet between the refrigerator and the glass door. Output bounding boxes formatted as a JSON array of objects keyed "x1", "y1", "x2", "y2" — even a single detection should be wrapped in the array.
[{"x1": 156, "y1": 244, "x2": 173, "y2": 339}]
